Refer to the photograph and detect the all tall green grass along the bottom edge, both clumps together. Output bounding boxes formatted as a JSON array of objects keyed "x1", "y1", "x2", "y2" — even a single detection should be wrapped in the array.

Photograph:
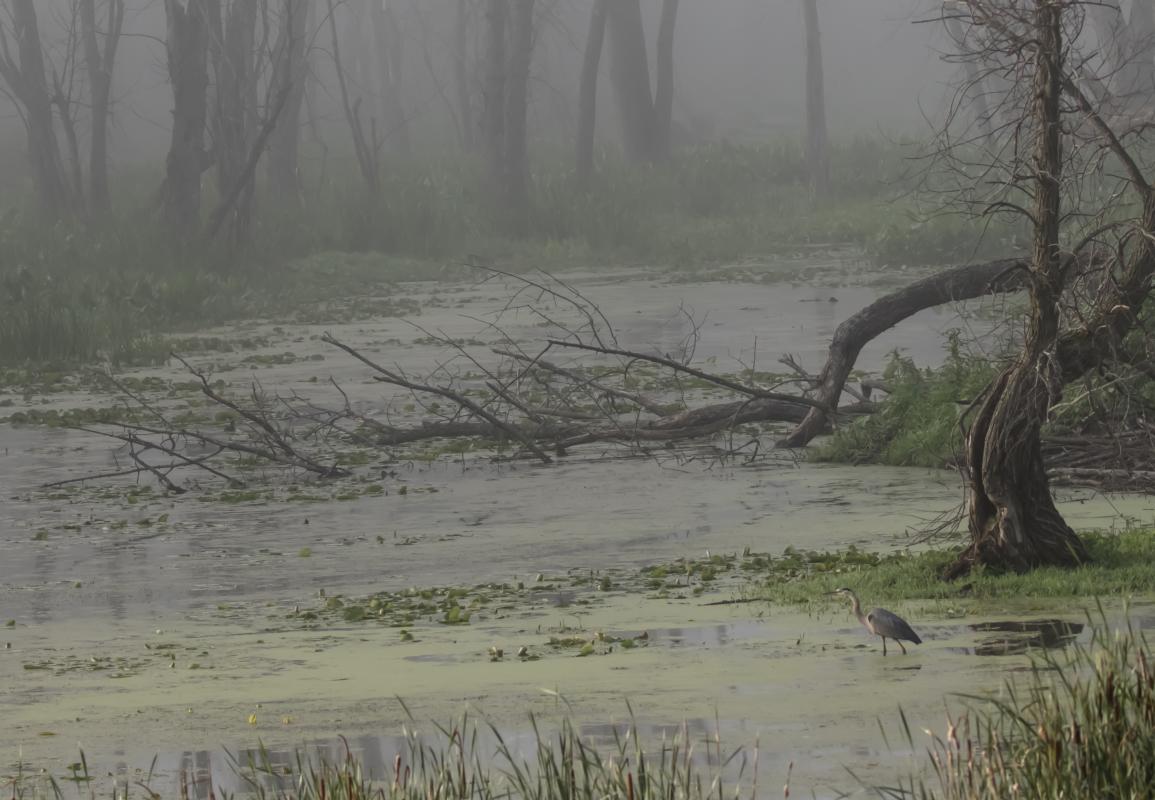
[{"x1": 6, "y1": 608, "x2": 1155, "y2": 800}]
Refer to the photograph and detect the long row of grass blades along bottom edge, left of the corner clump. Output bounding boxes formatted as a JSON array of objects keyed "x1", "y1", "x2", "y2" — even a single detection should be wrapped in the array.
[{"x1": 8, "y1": 716, "x2": 758, "y2": 800}]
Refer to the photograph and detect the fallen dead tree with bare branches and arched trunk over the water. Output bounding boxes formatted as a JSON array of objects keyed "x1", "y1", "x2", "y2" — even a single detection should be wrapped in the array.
[{"x1": 51, "y1": 260, "x2": 1155, "y2": 491}]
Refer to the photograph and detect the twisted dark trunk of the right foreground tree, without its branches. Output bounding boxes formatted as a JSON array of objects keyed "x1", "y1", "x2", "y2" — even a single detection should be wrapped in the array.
[{"x1": 947, "y1": 2, "x2": 1088, "y2": 577}]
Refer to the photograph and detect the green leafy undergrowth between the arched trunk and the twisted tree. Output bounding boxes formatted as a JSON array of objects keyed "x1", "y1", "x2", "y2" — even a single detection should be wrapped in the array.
[{"x1": 811, "y1": 331, "x2": 998, "y2": 468}]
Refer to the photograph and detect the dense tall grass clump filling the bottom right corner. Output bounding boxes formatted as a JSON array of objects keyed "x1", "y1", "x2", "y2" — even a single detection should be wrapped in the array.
[{"x1": 902, "y1": 619, "x2": 1155, "y2": 800}]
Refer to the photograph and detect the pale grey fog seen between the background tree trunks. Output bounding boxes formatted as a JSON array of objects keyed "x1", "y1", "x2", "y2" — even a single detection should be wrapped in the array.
[{"x1": 0, "y1": 0, "x2": 957, "y2": 176}]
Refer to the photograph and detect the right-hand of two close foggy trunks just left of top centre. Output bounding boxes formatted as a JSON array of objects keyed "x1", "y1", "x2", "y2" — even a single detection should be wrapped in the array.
[{"x1": 502, "y1": 0, "x2": 534, "y2": 227}]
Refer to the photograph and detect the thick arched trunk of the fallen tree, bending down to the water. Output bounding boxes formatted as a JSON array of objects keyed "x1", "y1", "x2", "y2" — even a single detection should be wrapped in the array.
[{"x1": 777, "y1": 259, "x2": 1026, "y2": 447}]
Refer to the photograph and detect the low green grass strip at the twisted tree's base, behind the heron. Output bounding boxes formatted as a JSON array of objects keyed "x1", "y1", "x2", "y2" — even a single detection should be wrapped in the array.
[{"x1": 751, "y1": 528, "x2": 1155, "y2": 604}]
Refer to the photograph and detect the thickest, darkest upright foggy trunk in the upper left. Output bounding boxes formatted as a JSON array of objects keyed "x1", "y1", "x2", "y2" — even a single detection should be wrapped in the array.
[{"x1": 161, "y1": 0, "x2": 218, "y2": 230}]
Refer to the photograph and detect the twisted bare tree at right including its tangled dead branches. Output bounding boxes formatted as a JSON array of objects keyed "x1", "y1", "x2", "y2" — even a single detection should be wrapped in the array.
[{"x1": 938, "y1": 0, "x2": 1155, "y2": 576}]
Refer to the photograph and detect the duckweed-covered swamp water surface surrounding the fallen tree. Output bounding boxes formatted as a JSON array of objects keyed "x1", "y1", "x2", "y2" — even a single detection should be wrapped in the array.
[{"x1": 0, "y1": 262, "x2": 1155, "y2": 797}]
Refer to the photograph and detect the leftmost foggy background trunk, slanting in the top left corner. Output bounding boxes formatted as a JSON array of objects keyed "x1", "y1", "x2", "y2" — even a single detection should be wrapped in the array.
[{"x1": 0, "y1": 0, "x2": 69, "y2": 218}]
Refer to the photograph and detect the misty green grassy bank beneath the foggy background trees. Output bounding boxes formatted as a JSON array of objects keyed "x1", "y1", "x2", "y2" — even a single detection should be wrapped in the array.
[{"x1": 0, "y1": 139, "x2": 1015, "y2": 364}]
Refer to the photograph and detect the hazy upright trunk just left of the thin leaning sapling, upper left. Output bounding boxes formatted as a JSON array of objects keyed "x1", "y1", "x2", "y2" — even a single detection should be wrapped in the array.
[{"x1": 268, "y1": 0, "x2": 310, "y2": 208}]
